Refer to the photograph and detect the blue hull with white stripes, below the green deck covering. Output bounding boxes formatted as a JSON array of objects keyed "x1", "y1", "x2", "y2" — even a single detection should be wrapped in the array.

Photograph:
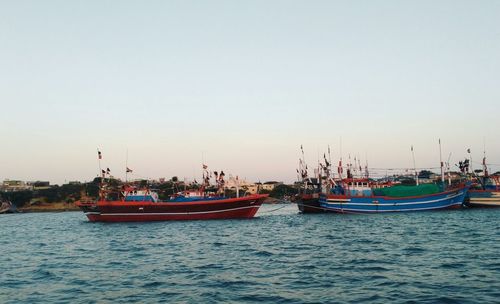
[{"x1": 320, "y1": 187, "x2": 468, "y2": 213}]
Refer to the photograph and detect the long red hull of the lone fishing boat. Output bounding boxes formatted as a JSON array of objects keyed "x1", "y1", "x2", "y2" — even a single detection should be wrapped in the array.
[{"x1": 78, "y1": 194, "x2": 267, "y2": 222}]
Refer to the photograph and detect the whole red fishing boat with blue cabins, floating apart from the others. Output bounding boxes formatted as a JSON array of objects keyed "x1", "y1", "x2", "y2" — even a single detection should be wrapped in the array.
[{"x1": 76, "y1": 156, "x2": 268, "y2": 222}]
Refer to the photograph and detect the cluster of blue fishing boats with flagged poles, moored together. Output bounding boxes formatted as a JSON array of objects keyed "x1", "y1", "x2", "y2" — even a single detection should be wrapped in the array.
[{"x1": 296, "y1": 147, "x2": 500, "y2": 213}]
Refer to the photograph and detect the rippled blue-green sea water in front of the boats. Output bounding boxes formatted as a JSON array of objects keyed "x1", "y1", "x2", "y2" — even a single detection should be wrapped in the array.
[{"x1": 0, "y1": 204, "x2": 500, "y2": 303}]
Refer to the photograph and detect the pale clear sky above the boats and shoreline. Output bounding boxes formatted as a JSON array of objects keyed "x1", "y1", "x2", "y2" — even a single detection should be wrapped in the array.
[{"x1": 0, "y1": 0, "x2": 500, "y2": 183}]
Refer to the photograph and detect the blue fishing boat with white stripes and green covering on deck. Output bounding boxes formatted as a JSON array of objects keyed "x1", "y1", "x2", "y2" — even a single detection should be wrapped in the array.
[{"x1": 319, "y1": 184, "x2": 469, "y2": 213}]
